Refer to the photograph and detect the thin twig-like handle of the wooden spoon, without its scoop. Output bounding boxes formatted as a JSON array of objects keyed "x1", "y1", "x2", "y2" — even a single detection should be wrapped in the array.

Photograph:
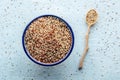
[{"x1": 79, "y1": 26, "x2": 90, "y2": 70}]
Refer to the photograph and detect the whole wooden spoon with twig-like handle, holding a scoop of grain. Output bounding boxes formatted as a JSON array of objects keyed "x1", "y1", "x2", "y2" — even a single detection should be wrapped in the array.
[{"x1": 79, "y1": 9, "x2": 98, "y2": 70}]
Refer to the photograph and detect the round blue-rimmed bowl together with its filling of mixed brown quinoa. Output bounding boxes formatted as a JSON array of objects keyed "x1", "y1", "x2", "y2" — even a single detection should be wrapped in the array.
[{"x1": 22, "y1": 15, "x2": 74, "y2": 66}]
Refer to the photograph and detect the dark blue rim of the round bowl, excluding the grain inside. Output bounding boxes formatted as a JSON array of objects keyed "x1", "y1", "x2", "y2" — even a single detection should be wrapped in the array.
[{"x1": 22, "y1": 15, "x2": 74, "y2": 66}]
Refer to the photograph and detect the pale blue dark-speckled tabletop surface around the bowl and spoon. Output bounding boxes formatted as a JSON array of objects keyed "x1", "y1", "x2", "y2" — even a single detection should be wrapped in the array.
[{"x1": 0, "y1": 0, "x2": 120, "y2": 80}]
